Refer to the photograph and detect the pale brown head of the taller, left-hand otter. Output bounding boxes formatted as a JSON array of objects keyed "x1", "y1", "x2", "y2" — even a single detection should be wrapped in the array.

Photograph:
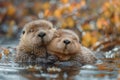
[{"x1": 21, "y1": 20, "x2": 55, "y2": 46}]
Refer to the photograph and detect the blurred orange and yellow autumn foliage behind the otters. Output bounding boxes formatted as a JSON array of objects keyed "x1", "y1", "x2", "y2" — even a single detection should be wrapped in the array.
[{"x1": 0, "y1": 0, "x2": 120, "y2": 51}]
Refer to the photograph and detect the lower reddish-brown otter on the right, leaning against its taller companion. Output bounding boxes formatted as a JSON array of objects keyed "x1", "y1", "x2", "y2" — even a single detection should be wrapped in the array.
[{"x1": 47, "y1": 29, "x2": 97, "y2": 66}]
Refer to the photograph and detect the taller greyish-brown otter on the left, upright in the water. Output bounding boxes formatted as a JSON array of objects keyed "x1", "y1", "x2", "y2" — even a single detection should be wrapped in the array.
[{"x1": 16, "y1": 20, "x2": 55, "y2": 62}]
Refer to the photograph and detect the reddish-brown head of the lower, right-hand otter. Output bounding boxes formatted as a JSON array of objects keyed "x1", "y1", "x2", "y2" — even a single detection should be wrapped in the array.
[{"x1": 48, "y1": 29, "x2": 80, "y2": 55}]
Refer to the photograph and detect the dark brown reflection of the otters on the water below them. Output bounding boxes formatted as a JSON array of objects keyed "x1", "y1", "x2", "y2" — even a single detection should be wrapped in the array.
[{"x1": 23, "y1": 67, "x2": 80, "y2": 80}]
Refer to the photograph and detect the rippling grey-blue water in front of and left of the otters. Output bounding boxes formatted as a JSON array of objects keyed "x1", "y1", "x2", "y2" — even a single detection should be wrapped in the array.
[{"x1": 0, "y1": 40, "x2": 120, "y2": 80}]
